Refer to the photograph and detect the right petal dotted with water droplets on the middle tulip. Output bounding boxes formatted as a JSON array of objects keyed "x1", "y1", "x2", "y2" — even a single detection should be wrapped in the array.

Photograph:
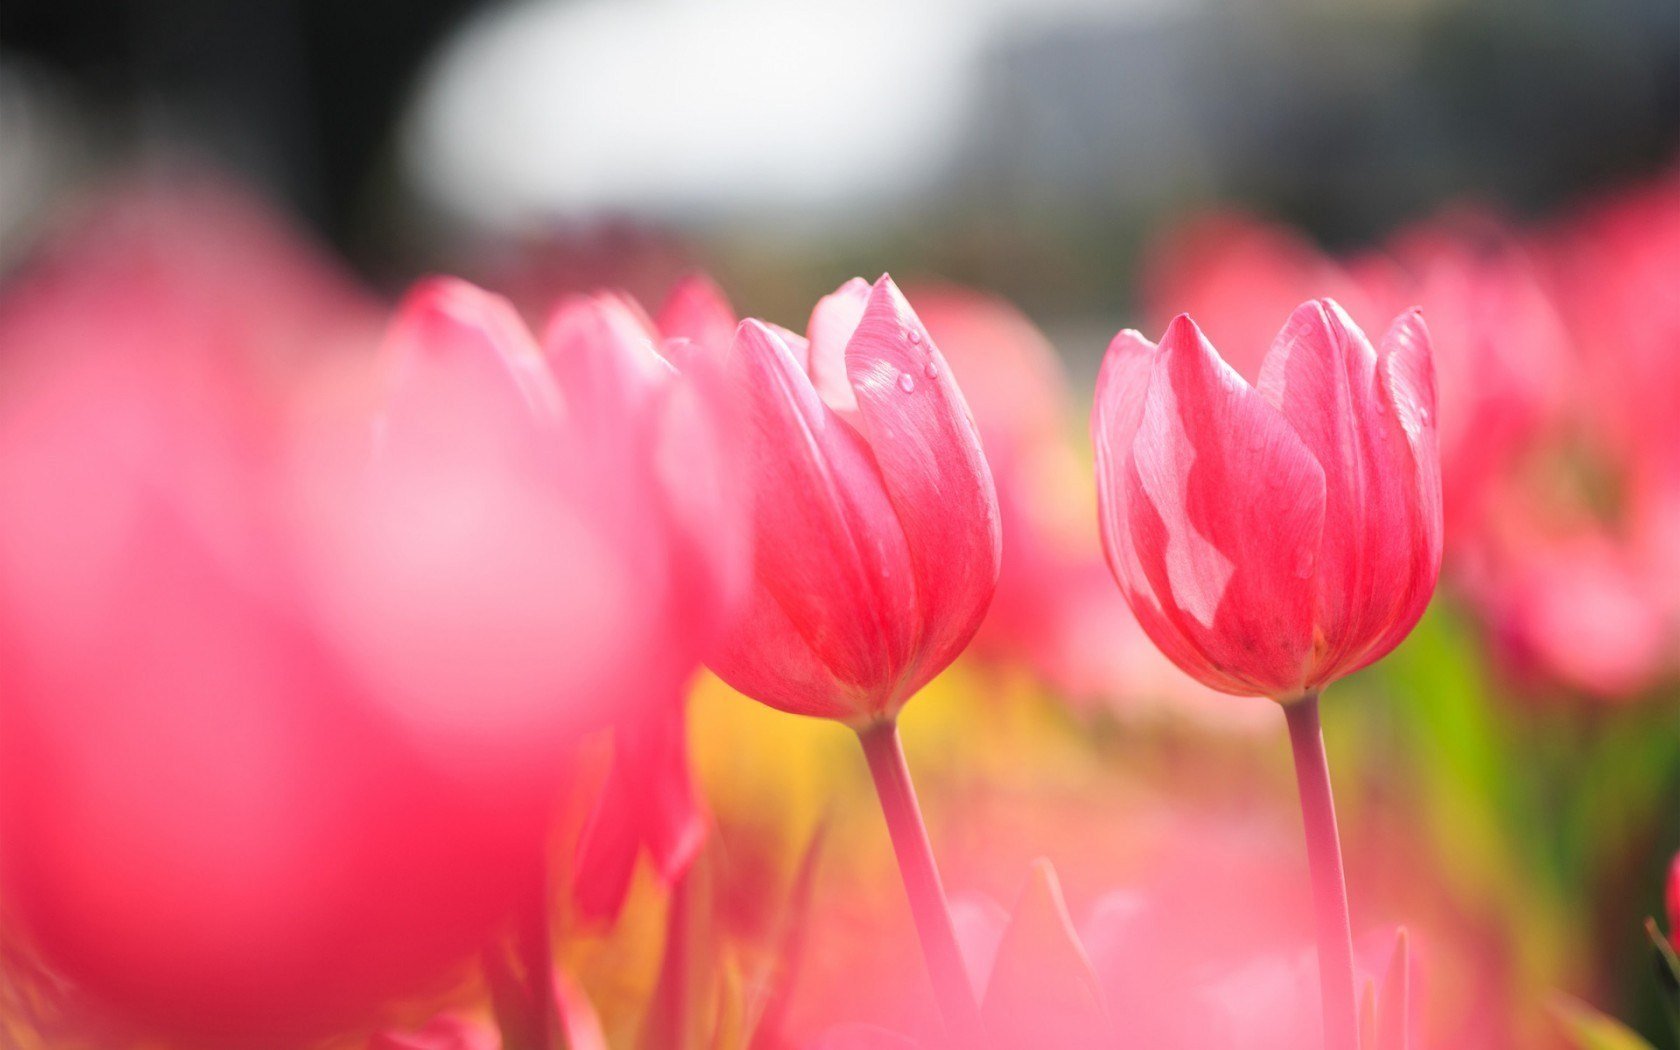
[{"x1": 840, "y1": 277, "x2": 1001, "y2": 701}]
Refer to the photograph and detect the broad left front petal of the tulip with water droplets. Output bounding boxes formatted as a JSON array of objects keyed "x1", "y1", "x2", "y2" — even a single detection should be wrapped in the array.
[{"x1": 714, "y1": 321, "x2": 917, "y2": 714}]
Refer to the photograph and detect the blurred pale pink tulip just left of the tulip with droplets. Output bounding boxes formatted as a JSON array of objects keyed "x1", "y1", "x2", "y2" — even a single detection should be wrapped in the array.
[{"x1": 305, "y1": 279, "x2": 736, "y2": 785}]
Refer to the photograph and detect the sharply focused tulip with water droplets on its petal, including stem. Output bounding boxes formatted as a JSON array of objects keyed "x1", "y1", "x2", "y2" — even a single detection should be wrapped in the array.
[{"x1": 698, "y1": 277, "x2": 1000, "y2": 1033}]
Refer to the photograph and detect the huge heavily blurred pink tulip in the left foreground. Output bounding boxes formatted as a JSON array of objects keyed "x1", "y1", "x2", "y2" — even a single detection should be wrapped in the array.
[{"x1": 0, "y1": 258, "x2": 536, "y2": 1043}]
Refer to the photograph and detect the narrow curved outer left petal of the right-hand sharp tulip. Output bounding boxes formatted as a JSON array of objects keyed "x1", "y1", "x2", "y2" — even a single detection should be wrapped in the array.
[{"x1": 1090, "y1": 329, "x2": 1248, "y2": 692}]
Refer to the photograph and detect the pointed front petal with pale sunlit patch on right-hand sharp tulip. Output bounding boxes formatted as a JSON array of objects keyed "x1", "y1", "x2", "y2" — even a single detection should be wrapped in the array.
[{"x1": 1126, "y1": 316, "x2": 1324, "y2": 699}]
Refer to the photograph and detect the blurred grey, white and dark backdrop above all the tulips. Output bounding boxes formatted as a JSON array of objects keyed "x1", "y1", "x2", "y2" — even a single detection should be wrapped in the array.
[{"x1": 0, "y1": 0, "x2": 1680, "y2": 376}]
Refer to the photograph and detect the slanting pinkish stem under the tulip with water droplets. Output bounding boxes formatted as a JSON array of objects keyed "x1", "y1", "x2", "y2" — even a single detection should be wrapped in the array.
[{"x1": 857, "y1": 721, "x2": 983, "y2": 1047}]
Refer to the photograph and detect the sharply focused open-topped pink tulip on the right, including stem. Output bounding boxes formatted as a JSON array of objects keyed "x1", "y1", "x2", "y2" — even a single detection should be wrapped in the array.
[{"x1": 1092, "y1": 299, "x2": 1441, "y2": 1048}]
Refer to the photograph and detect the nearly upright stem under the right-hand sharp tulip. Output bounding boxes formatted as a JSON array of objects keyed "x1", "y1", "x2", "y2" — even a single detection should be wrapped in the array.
[{"x1": 1284, "y1": 692, "x2": 1359, "y2": 1050}]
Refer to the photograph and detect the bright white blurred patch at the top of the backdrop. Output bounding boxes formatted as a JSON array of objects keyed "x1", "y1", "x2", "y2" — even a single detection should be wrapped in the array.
[{"x1": 402, "y1": 0, "x2": 1161, "y2": 228}]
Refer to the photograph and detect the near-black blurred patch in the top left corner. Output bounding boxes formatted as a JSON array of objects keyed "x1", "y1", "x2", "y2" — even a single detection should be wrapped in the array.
[{"x1": 0, "y1": 0, "x2": 472, "y2": 244}]
